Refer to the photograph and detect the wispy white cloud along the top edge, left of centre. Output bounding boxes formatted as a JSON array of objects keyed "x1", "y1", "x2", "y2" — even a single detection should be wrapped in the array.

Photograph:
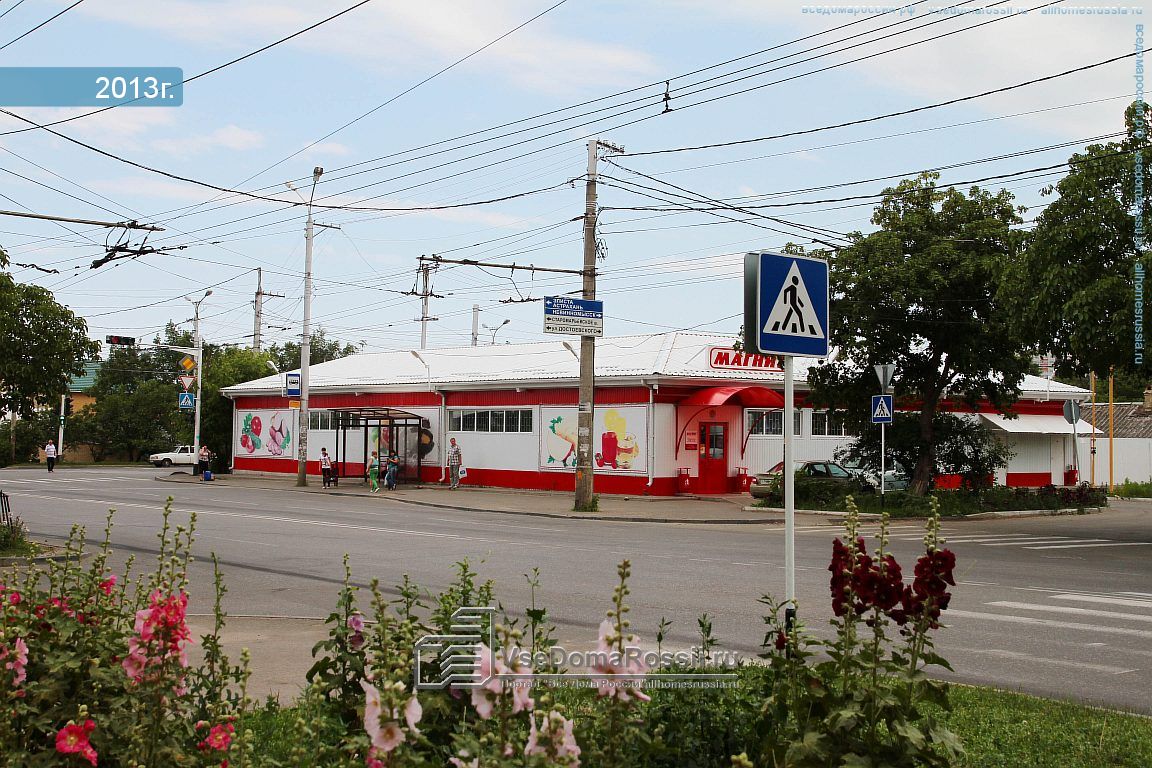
[{"x1": 77, "y1": 0, "x2": 653, "y2": 93}]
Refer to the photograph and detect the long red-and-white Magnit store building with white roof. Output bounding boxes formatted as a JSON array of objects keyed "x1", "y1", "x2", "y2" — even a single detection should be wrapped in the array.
[{"x1": 223, "y1": 333, "x2": 1091, "y2": 495}]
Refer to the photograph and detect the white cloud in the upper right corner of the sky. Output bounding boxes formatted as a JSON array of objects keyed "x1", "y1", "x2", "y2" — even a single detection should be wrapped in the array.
[{"x1": 677, "y1": 0, "x2": 1142, "y2": 138}]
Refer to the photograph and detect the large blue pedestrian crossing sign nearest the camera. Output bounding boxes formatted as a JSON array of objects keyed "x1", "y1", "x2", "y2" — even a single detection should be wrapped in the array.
[{"x1": 744, "y1": 252, "x2": 829, "y2": 357}]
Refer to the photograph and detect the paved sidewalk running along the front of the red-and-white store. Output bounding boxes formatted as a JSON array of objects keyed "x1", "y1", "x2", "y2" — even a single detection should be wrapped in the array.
[{"x1": 157, "y1": 472, "x2": 820, "y2": 525}]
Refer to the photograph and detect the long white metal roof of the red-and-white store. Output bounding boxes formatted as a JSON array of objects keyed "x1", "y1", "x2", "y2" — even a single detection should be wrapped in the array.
[{"x1": 221, "y1": 332, "x2": 1089, "y2": 400}]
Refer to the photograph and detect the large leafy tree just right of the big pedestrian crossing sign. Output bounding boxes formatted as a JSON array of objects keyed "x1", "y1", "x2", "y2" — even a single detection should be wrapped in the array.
[{"x1": 809, "y1": 174, "x2": 1031, "y2": 495}]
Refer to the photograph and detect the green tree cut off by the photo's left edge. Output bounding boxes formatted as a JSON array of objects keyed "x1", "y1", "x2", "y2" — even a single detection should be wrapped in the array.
[{"x1": 0, "y1": 251, "x2": 100, "y2": 417}]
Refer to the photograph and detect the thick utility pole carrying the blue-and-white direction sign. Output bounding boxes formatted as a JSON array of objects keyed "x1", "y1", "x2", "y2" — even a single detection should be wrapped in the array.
[{"x1": 575, "y1": 139, "x2": 623, "y2": 511}]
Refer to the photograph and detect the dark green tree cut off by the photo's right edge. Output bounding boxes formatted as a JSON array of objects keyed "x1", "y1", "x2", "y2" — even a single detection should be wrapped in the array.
[{"x1": 1001, "y1": 104, "x2": 1152, "y2": 377}]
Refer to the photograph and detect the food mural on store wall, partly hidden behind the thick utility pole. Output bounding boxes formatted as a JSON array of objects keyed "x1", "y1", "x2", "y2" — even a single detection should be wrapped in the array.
[{"x1": 540, "y1": 405, "x2": 647, "y2": 472}]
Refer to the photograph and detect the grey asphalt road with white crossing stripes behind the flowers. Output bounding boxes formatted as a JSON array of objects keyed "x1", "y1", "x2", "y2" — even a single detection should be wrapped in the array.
[{"x1": 0, "y1": 467, "x2": 1152, "y2": 714}]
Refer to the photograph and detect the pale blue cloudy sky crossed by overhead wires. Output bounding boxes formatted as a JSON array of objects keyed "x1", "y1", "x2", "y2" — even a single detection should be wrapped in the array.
[{"x1": 0, "y1": 0, "x2": 1152, "y2": 351}]
